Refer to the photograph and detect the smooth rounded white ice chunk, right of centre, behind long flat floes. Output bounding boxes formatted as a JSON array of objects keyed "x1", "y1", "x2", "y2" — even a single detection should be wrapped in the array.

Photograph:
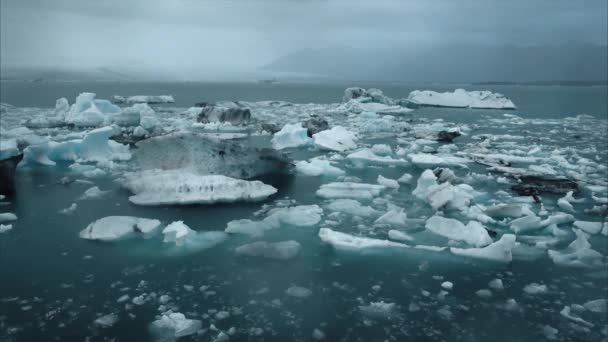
[{"x1": 425, "y1": 216, "x2": 492, "y2": 247}]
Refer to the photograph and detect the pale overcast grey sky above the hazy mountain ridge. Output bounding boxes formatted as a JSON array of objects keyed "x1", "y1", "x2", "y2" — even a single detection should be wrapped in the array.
[{"x1": 0, "y1": 0, "x2": 608, "y2": 77}]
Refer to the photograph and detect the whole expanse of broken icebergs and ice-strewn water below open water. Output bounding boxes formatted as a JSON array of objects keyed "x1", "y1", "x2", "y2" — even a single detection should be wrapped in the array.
[{"x1": 0, "y1": 88, "x2": 608, "y2": 341}]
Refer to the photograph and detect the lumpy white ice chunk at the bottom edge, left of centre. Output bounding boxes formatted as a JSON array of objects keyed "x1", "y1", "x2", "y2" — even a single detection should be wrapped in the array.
[{"x1": 149, "y1": 312, "x2": 202, "y2": 341}]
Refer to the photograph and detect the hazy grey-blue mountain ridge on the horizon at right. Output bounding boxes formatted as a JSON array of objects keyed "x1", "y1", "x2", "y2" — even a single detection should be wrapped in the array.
[{"x1": 262, "y1": 44, "x2": 608, "y2": 84}]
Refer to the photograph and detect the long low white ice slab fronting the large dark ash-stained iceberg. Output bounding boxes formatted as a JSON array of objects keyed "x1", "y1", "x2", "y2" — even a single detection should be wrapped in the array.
[{"x1": 122, "y1": 170, "x2": 277, "y2": 205}]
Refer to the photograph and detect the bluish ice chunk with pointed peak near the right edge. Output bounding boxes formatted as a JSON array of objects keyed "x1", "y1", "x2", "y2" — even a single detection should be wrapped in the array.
[{"x1": 548, "y1": 229, "x2": 604, "y2": 267}]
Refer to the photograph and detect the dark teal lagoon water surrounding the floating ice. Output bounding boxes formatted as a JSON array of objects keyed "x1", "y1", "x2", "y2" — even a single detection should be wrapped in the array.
[{"x1": 0, "y1": 82, "x2": 608, "y2": 341}]
